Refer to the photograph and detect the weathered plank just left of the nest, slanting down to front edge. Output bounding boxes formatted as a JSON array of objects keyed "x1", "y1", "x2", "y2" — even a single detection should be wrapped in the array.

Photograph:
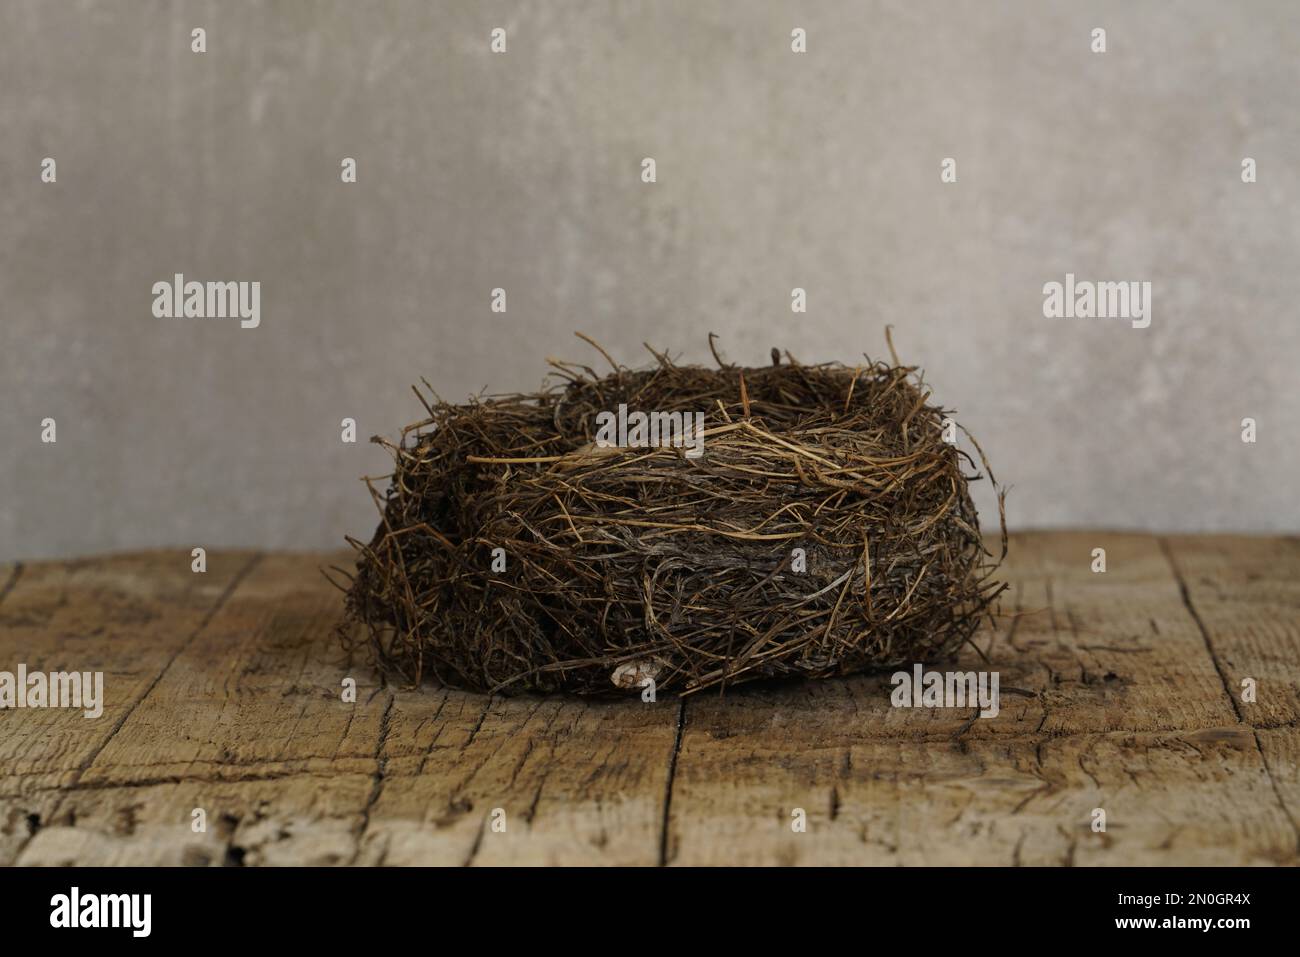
[{"x1": 10, "y1": 554, "x2": 389, "y2": 865}]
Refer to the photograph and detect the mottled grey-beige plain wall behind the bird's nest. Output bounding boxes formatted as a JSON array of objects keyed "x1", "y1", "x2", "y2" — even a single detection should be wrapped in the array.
[{"x1": 0, "y1": 0, "x2": 1300, "y2": 558}]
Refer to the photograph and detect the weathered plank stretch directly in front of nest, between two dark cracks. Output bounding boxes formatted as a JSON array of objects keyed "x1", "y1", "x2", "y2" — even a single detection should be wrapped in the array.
[{"x1": 359, "y1": 692, "x2": 680, "y2": 865}]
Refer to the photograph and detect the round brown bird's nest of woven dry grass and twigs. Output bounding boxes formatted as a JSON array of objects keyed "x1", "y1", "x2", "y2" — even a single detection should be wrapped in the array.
[{"x1": 341, "y1": 335, "x2": 1006, "y2": 694}]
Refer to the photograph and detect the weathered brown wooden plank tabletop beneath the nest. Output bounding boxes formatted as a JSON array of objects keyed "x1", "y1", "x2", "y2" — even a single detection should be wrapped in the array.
[{"x1": 0, "y1": 532, "x2": 1300, "y2": 865}]
